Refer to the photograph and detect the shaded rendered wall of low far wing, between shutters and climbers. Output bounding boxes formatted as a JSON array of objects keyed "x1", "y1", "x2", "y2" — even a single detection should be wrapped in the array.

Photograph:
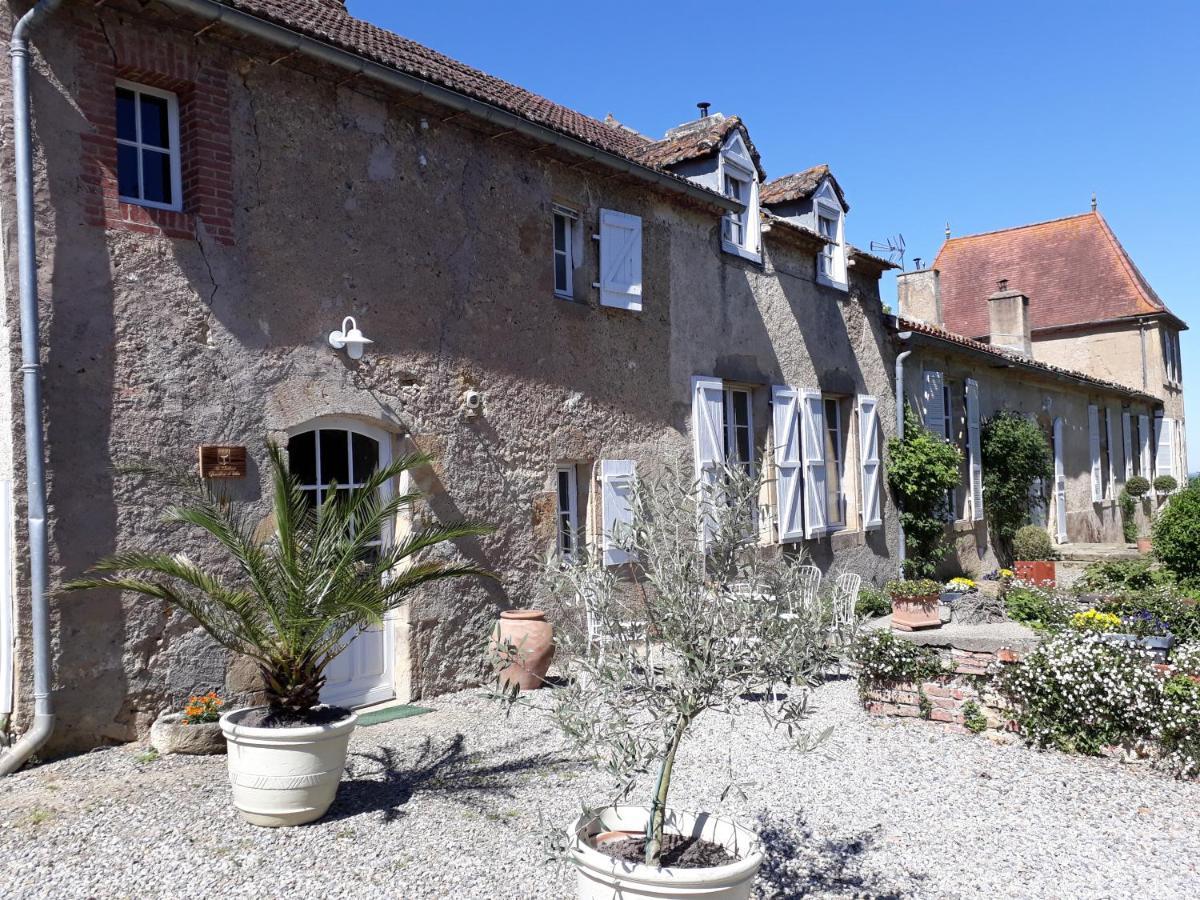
[{"x1": 905, "y1": 348, "x2": 1150, "y2": 576}]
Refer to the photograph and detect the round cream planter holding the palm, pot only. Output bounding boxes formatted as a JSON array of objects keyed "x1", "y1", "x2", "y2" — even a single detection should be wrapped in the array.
[{"x1": 221, "y1": 709, "x2": 359, "y2": 828}]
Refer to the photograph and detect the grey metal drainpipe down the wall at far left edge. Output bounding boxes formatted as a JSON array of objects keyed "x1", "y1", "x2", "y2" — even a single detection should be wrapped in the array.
[{"x1": 0, "y1": 0, "x2": 62, "y2": 775}]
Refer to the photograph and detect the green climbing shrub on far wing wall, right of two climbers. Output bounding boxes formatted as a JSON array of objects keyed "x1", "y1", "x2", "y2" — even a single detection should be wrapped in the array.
[{"x1": 979, "y1": 409, "x2": 1054, "y2": 563}]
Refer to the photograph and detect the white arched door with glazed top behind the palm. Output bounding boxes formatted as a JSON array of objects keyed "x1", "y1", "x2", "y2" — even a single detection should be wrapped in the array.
[{"x1": 288, "y1": 422, "x2": 396, "y2": 707}]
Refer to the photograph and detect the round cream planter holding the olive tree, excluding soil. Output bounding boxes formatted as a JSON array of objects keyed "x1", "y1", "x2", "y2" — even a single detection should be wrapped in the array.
[{"x1": 568, "y1": 806, "x2": 762, "y2": 900}]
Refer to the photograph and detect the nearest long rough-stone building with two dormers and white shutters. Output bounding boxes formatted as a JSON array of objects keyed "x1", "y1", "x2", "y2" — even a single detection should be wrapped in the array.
[{"x1": 0, "y1": 0, "x2": 898, "y2": 751}]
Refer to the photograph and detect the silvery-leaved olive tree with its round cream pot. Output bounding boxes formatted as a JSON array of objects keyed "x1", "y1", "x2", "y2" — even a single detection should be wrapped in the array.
[{"x1": 493, "y1": 466, "x2": 834, "y2": 900}]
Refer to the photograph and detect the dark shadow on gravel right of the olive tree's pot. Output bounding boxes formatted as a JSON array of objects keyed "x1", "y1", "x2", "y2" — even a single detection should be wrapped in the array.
[{"x1": 757, "y1": 814, "x2": 913, "y2": 900}]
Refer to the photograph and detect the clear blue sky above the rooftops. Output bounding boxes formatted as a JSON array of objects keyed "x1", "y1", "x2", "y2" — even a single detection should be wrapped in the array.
[{"x1": 349, "y1": 0, "x2": 1200, "y2": 472}]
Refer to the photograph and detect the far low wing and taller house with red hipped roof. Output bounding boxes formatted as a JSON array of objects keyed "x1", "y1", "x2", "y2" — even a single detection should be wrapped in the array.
[{"x1": 896, "y1": 210, "x2": 1187, "y2": 571}]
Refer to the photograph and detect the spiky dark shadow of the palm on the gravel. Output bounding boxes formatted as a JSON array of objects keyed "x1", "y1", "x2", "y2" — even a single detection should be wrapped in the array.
[{"x1": 320, "y1": 734, "x2": 571, "y2": 822}]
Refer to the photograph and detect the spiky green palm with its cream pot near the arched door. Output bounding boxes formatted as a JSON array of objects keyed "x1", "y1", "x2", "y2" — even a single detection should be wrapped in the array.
[{"x1": 66, "y1": 444, "x2": 490, "y2": 827}]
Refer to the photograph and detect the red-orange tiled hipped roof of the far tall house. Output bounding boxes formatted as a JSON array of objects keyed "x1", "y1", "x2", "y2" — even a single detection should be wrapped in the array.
[{"x1": 934, "y1": 211, "x2": 1170, "y2": 336}]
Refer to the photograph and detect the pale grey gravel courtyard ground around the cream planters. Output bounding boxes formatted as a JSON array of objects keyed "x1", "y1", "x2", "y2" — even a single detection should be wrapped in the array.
[{"x1": 0, "y1": 682, "x2": 1200, "y2": 900}]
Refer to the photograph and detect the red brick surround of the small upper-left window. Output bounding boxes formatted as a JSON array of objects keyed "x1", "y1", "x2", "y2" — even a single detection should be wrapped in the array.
[{"x1": 78, "y1": 19, "x2": 234, "y2": 245}]
